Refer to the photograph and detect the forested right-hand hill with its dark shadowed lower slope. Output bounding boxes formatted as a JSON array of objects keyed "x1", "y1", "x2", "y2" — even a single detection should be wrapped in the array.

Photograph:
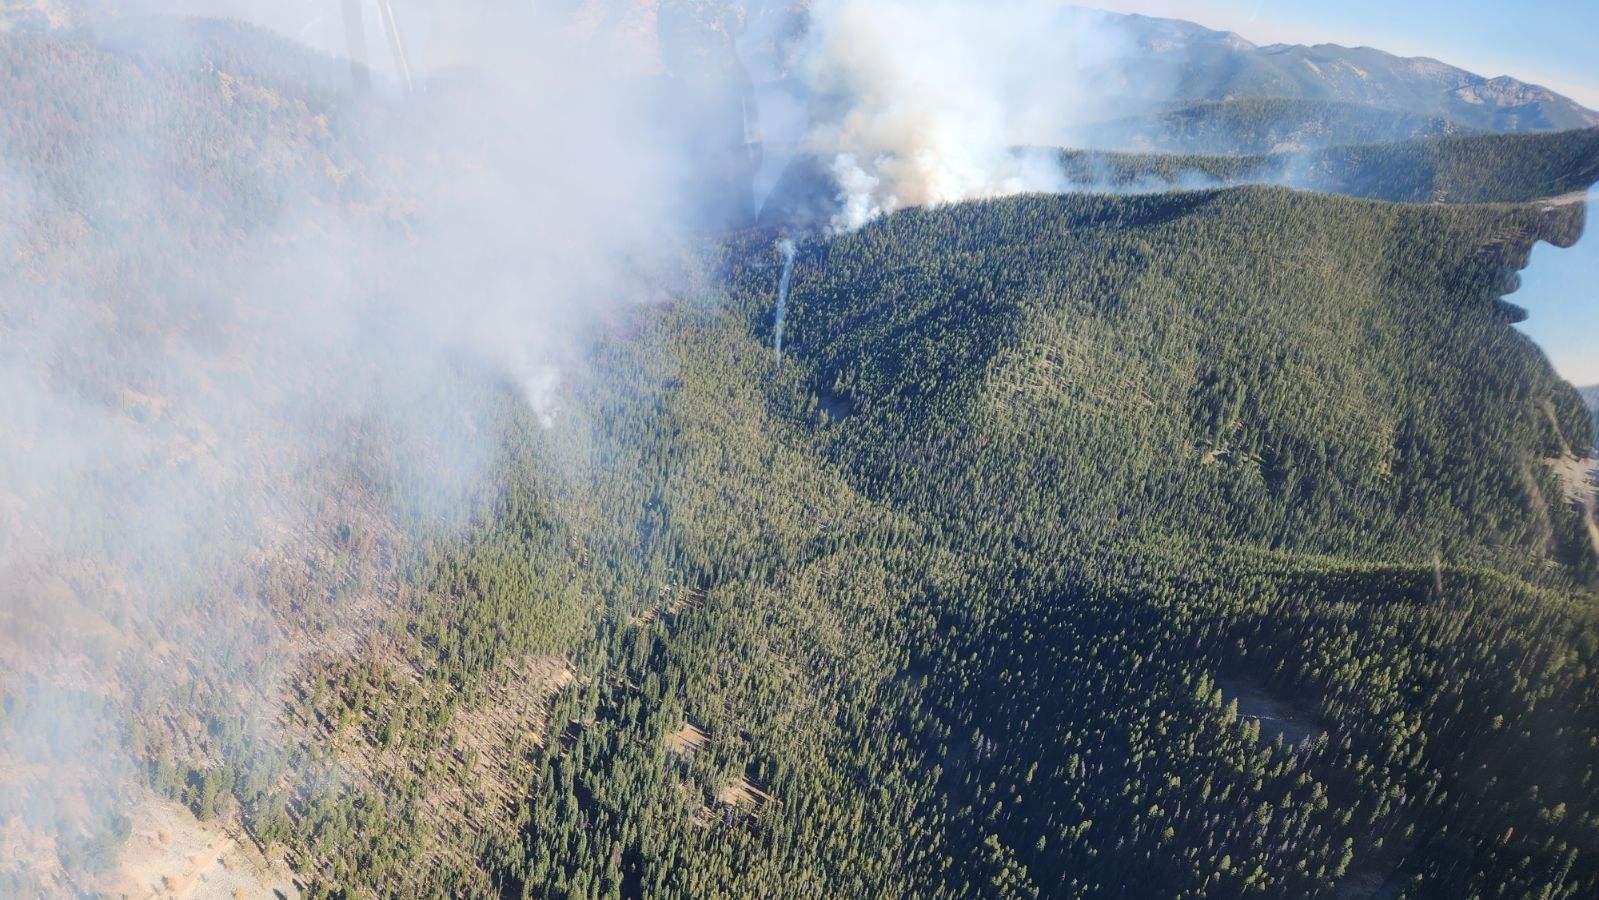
[{"x1": 693, "y1": 183, "x2": 1596, "y2": 895}]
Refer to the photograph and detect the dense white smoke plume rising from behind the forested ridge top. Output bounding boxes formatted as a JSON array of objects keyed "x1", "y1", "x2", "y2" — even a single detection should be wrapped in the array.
[{"x1": 804, "y1": 0, "x2": 1127, "y2": 230}]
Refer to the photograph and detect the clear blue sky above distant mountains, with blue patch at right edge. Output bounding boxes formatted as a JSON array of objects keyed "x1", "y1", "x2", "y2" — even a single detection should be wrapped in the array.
[{"x1": 1086, "y1": 0, "x2": 1599, "y2": 385}]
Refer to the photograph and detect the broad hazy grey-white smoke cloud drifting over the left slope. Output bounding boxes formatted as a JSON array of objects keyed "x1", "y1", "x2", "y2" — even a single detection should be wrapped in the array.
[{"x1": 0, "y1": 0, "x2": 720, "y2": 874}]
